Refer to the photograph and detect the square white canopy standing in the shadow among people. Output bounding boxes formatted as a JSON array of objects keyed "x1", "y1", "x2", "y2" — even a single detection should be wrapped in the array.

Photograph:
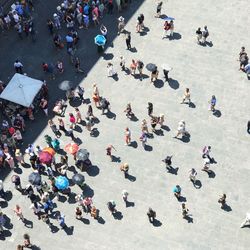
[{"x1": 0, "y1": 73, "x2": 43, "y2": 107}]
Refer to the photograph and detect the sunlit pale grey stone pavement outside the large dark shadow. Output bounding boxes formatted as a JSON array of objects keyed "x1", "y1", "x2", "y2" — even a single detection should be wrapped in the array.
[{"x1": 0, "y1": 0, "x2": 250, "y2": 250}]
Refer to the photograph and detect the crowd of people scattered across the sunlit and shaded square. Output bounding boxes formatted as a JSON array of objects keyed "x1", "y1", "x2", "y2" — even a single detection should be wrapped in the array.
[{"x1": 0, "y1": 0, "x2": 250, "y2": 249}]
